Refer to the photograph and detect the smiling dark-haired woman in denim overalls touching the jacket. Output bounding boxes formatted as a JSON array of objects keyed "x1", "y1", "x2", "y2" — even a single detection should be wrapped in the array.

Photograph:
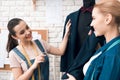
[{"x1": 7, "y1": 18, "x2": 71, "y2": 80}]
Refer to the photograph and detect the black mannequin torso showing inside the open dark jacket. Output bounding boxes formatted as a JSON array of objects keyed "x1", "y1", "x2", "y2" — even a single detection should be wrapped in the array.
[{"x1": 78, "y1": 12, "x2": 92, "y2": 45}]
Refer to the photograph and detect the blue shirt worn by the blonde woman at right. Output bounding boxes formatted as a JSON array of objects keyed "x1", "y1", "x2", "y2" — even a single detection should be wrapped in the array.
[{"x1": 84, "y1": 36, "x2": 120, "y2": 80}]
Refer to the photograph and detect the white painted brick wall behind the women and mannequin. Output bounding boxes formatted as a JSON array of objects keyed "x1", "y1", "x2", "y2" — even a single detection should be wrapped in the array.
[{"x1": 0, "y1": 0, "x2": 82, "y2": 80}]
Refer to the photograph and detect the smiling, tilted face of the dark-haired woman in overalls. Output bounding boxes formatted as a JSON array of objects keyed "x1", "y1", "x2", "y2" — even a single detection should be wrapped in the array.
[{"x1": 13, "y1": 21, "x2": 32, "y2": 42}]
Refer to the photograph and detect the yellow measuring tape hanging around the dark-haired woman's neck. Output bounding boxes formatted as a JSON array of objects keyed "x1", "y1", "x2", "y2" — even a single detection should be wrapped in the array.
[{"x1": 20, "y1": 42, "x2": 40, "y2": 80}]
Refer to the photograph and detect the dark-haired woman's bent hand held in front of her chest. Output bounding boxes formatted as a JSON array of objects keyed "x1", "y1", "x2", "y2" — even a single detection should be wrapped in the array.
[{"x1": 32, "y1": 54, "x2": 45, "y2": 69}]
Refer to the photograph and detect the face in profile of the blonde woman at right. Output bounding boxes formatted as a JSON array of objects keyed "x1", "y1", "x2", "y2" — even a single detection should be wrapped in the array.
[{"x1": 91, "y1": 8, "x2": 107, "y2": 36}]
